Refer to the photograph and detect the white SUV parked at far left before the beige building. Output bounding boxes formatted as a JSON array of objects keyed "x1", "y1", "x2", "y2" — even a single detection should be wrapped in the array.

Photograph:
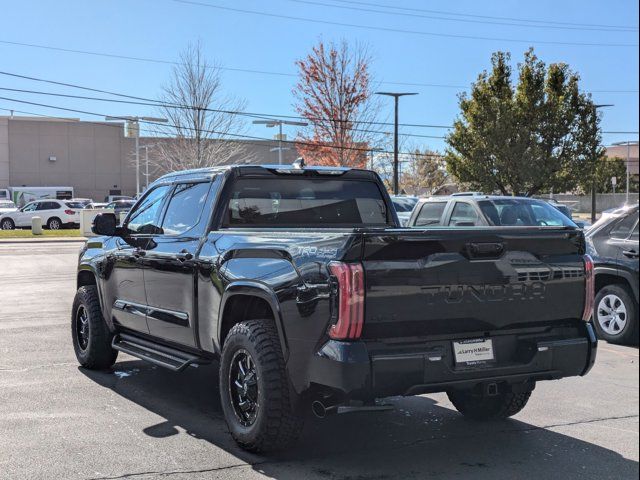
[{"x1": 0, "y1": 199, "x2": 80, "y2": 230}]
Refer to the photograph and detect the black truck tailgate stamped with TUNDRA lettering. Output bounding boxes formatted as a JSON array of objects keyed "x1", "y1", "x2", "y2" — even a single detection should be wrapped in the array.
[{"x1": 362, "y1": 227, "x2": 585, "y2": 339}]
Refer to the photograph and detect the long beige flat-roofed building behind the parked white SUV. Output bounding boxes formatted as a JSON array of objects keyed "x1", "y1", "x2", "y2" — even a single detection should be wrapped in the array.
[{"x1": 0, "y1": 116, "x2": 297, "y2": 201}]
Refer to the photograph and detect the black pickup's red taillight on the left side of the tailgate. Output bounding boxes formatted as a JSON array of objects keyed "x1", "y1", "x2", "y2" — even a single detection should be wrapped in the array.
[{"x1": 329, "y1": 262, "x2": 364, "y2": 340}]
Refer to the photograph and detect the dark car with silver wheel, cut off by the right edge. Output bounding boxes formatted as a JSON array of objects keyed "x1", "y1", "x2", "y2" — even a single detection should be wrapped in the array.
[{"x1": 586, "y1": 205, "x2": 640, "y2": 344}]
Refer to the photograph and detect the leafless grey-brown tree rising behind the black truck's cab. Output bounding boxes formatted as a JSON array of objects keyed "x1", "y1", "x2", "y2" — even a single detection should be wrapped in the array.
[{"x1": 152, "y1": 42, "x2": 246, "y2": 172}]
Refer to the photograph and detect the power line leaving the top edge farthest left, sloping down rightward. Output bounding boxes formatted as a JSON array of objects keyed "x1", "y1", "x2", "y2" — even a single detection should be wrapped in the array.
[{"x1": 172, "y1": 0, "x2": 638, "y2": 48}]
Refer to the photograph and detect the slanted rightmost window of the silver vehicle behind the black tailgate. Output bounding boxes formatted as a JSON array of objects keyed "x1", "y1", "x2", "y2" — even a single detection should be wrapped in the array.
[{"x1": 478, "y1": 198, "x2": 576, "y2": 227}]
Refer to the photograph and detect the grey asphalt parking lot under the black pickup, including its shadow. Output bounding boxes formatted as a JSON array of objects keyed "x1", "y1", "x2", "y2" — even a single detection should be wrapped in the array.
[{"x1": 0, "y1": 243, "x2": 639, "y2": 480}]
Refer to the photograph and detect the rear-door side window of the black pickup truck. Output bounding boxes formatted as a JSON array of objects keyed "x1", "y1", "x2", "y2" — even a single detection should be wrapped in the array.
[{"x1": 162, "y1": 182, "x2": 211, "y2": 235}]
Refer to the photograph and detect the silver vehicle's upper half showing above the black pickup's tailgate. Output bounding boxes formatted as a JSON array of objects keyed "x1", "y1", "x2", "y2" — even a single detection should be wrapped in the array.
[{"x1": 407, "y1": 195, "x2": 577, "y2": 228}]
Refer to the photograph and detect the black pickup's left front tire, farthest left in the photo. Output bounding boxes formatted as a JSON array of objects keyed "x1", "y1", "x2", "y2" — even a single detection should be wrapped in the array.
[{"x1": 71, "y1": 285, "x2": 118, "y2": 370}]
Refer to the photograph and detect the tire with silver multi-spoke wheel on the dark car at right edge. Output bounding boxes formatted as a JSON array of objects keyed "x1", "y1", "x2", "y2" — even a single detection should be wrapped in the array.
[{"x1": 593, "y1": 284, "x2": 638, "y2": 344}]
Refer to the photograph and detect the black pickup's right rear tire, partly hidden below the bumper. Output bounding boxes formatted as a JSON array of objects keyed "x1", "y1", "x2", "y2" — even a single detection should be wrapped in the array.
[{"x1": 447, "y1": 385, "x2": 531, "y2": 421}]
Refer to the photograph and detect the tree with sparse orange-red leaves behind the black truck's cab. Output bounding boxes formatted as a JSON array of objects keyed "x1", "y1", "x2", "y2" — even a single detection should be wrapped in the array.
[{"x1": 293, "y1": 41, "x2": 379, "y2": 168}]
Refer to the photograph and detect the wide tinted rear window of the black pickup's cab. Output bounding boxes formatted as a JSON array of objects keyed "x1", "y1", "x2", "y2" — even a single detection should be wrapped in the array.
[{"x1": 225, "y1": 177, "x2": 389, "y2": 227}]
